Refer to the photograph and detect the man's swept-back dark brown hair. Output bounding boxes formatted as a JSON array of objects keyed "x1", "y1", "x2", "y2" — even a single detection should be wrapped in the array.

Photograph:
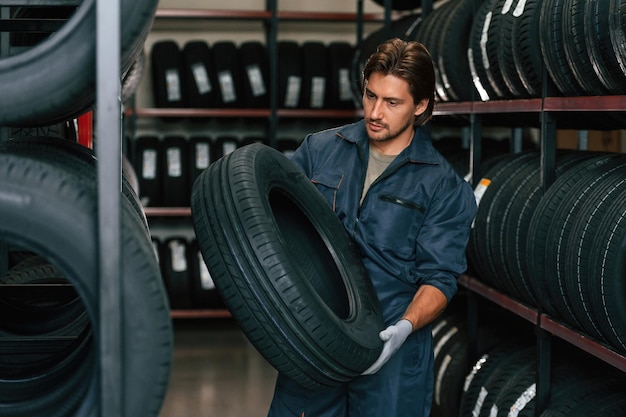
[{"x1": 362, "y1": 38, "x2": 435, "y2": 126}]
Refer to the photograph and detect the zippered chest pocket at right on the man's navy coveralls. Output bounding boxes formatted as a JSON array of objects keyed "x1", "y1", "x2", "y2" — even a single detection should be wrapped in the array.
[{"x1": 361, "y1": 193, "x2": 428, "y2": 259}]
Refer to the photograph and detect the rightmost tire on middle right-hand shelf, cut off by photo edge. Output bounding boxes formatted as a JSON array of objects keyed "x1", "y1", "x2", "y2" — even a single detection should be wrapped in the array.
[{"x1": 564, "y1": 169, "x2": 626, "y2": 352}]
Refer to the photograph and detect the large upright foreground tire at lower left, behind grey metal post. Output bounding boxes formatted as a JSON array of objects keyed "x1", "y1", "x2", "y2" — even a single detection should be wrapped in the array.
[{"x1": 0, "y1": 145, "x2": 173, "y2": 417}]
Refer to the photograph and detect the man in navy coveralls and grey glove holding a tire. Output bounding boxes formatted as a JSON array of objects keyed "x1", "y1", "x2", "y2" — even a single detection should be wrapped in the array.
[{"x1": 269, "y1": 39, "x2": 476, "y2": 417}]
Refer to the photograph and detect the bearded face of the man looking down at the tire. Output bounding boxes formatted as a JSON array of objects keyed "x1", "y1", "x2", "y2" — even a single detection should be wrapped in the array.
[{"x1": 363, "y1": 72, "x2": 428, "y2": 143}]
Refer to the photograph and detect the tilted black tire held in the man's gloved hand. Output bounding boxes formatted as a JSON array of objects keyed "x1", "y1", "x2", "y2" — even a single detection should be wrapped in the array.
[{"x1": 191, "y1": 143, "x2": 384, "y2": 389}]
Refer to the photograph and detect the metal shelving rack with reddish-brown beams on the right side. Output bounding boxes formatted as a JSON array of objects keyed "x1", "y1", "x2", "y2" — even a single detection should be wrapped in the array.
[{"x1": 434, "y1": 92, "x2": 626, "y2": 417}]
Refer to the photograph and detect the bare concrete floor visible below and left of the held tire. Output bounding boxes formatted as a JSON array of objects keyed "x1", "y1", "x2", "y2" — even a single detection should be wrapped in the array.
[{"x1": 159, "y1": 319, "x2": 276, "y2": 417}]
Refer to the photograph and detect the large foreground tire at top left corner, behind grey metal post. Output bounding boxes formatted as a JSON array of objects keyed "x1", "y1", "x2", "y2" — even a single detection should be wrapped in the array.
[{"x1": 0, "y1": 0, "x2": 158, "y2": 126}]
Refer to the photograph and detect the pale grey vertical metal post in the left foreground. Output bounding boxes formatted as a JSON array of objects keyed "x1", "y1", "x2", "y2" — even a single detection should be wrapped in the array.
[{"x1": 95, "y1": 0, "x2": 125, "y2": 417}]
